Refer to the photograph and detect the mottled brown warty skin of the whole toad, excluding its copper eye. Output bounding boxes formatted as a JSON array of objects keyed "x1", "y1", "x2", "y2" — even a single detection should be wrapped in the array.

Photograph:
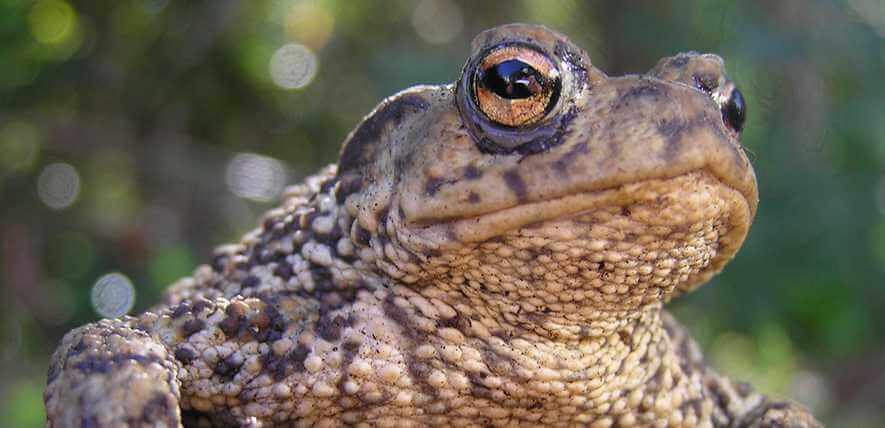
[{"x1": 45, "y1": 25, "x2": 819, "y2": 427}]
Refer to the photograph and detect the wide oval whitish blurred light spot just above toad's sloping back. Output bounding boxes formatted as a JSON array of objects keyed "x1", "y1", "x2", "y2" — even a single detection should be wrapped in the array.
[{"x1": 226, "y1": 153, "x2": 286, "y2": 202}]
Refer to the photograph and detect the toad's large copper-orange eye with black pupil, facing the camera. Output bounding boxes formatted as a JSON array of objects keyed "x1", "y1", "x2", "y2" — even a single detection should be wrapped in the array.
[{"x1": 472, "y1": 46, "x2": 561, "y2": 128}]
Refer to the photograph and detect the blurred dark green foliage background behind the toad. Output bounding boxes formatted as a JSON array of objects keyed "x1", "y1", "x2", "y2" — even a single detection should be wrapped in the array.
[{"x1": 0, "y1": 0, "x2": 885, "y2": 427}]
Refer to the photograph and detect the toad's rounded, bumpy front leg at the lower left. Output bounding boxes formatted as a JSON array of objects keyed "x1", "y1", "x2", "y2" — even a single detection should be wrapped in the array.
[{"x1": 44, "y1": 319, "x2": 181, "y2": 427}]
